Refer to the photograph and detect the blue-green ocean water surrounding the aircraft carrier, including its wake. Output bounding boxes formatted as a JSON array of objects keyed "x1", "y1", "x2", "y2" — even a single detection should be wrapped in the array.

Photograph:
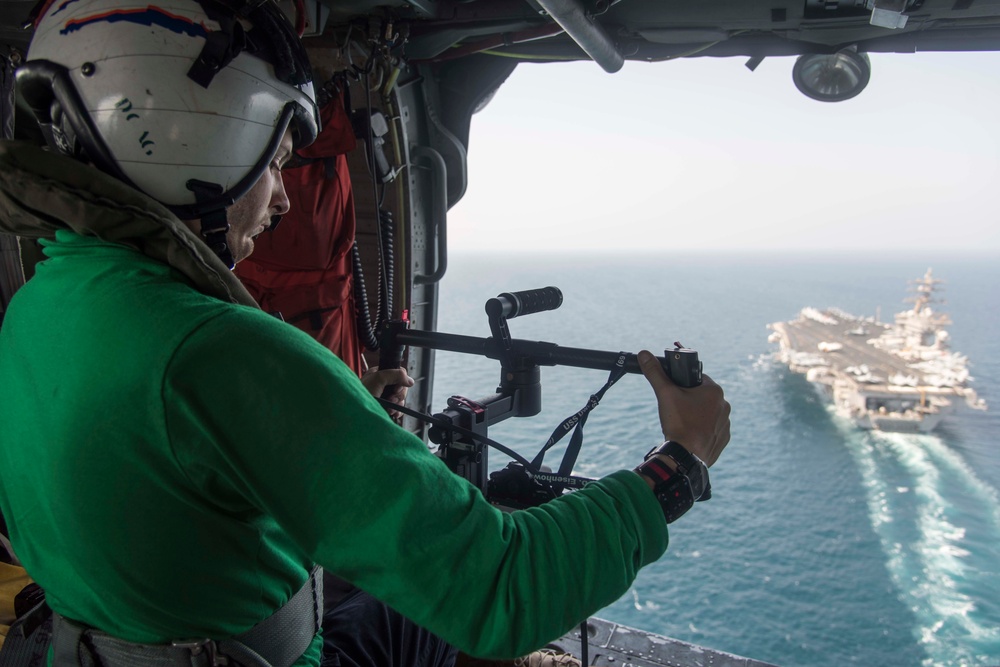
[{"x1": 434, "y1": 255, "x2": 1000, "y2": 667}]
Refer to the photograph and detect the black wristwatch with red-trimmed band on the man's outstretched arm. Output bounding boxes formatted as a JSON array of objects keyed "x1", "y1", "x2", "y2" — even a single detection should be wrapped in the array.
[{"x1": 635, "y1": 440, "x2": 708, "y2": 523}]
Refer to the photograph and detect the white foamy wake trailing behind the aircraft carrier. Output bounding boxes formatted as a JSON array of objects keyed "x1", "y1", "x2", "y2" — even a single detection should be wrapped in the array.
[{"x1": 845, "y1": 427, "x2": 1000, "y2": 667}]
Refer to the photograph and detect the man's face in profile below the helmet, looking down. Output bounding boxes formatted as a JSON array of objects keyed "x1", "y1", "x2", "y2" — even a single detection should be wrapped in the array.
[{"x1": 226, "y1": 130, "x2": 292, "y2": 262}]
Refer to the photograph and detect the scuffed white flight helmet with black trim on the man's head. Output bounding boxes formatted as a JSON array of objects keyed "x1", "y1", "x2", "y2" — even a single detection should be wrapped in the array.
[{"x1": 17, "y1": 0, "x2": 319, "y2": 224}]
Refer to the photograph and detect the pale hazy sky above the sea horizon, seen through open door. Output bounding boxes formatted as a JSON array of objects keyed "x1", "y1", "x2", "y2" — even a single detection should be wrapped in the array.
[{"x1": 448, "y1": 53, "x2": 1000, "y2": 254}]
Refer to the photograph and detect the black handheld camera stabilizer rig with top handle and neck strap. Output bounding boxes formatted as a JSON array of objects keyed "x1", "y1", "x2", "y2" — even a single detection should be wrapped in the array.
[{"x1": 379, "y1": 287, "x2": 708, "y2": 509}]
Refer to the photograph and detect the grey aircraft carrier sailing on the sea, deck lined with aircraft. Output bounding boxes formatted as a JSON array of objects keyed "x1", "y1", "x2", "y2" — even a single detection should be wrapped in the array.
[{"x1": 768, "y1": 269, "x2": 986, "y2": 433}]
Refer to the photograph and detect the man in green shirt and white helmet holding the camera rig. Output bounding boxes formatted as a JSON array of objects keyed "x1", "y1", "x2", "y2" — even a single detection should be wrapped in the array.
[{"x1": 0, "y1": 0, "x2": 729, "y2": 665}]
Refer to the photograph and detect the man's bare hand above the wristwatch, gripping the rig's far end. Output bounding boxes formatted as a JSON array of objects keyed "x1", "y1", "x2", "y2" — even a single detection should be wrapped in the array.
[{"x1": 637, "y1": 350, "x2": 731, "y2": 466}]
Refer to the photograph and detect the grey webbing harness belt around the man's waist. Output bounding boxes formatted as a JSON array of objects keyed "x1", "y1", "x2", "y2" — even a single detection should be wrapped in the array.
[{"x1": 52, "y1": 567, "x2": 323, "y2": 667}]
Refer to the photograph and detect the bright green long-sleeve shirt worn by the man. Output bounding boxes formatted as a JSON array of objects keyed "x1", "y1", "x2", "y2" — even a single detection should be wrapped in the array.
[{"x1": 0, "y1": 141, "x2": 667, "y2": 665}]
